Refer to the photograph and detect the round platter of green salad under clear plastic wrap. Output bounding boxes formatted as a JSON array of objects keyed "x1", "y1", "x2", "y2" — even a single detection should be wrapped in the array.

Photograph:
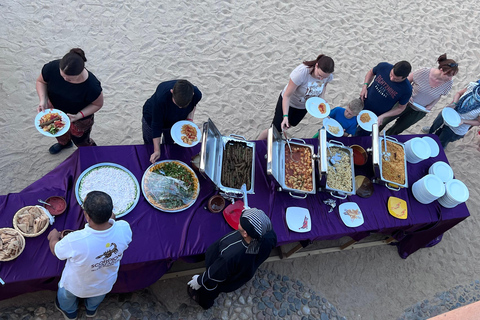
[{"x1": 142, "y1": 160, "x2": 200, "y2": 212}]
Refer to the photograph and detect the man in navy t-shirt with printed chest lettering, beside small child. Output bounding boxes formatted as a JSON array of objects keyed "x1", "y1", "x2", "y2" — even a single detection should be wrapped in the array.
[{"x1": 355, "y1": 61, "x2": 412, "y2": 136}]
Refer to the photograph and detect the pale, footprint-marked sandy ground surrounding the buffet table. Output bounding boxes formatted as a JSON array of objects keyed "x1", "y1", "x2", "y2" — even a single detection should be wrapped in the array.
[{"x1": 0, "y1": 0, "x2": 480, "y2": 319}]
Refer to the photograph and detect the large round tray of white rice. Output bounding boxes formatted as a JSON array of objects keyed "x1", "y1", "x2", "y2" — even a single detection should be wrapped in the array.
[{"x1": 75, "y1": 162, "x2": 140, "y2": 218}]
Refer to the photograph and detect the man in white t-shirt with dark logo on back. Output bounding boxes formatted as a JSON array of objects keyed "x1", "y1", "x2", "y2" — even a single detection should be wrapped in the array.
[{"x1": 48, "y1": 191, "x2": 132, "y2": 319}]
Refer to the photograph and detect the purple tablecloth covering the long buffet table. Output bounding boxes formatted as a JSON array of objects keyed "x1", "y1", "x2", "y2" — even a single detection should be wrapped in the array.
[{"x1": 0, "y1": 135, "x2": 469, "y2": 300}]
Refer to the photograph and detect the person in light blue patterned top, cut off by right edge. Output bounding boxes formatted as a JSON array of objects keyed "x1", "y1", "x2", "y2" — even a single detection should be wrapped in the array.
[{"x1": 422, "y1": 80, "x2": 480, "y2": 149}]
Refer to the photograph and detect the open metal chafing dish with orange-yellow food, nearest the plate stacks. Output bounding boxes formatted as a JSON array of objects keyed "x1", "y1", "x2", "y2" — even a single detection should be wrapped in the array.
[{"x1": 369, "y1": 123, "x2": 408, "y2": 191}]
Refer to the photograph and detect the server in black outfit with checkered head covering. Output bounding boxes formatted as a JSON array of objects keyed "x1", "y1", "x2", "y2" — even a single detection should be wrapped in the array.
[{"x1": 187, "y1": 208, "x2": 277, "y2": 309}]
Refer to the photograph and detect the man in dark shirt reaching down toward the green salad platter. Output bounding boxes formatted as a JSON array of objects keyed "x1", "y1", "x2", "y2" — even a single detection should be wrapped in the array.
[{"x1": 142, "y1": 80, "x2": 202, "y2": 163}]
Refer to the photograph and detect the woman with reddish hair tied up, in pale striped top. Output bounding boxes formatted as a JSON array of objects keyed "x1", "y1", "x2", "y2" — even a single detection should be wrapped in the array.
[{"x1": 379, "y1": 53, "x2": 458, "y2": 136}]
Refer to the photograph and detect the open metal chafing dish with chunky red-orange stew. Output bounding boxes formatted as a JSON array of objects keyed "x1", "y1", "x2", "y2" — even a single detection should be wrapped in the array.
[{"x1": 266, "y1": 126, "x2": 316, "y2": 199}]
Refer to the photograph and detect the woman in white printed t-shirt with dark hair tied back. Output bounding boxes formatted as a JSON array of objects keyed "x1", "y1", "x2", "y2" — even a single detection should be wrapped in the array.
[{"x1": 257, "y1": 54, "x2": 335, "y2": 140}]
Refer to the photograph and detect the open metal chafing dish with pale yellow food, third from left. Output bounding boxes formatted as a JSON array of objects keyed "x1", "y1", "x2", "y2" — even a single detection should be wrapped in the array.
[{"x1": 318, "y1": 129, "x2": 355, "y2": 199}]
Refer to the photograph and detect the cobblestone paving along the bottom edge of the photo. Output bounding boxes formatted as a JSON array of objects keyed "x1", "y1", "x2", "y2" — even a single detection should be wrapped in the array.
[{"x1": 0, "y1": 269, "x2": 480, "y2": 320}]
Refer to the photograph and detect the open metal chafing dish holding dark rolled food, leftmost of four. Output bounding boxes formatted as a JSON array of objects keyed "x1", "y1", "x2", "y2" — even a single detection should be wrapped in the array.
[{"x1": 199, "y1": 119, "x2": 255, "y2": 195}]
